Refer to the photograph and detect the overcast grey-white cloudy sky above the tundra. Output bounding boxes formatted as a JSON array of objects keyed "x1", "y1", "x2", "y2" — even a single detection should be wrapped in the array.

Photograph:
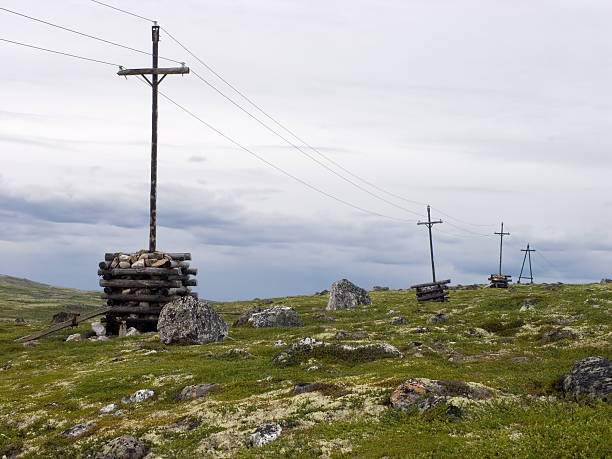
[{"x1": 0, "y1": 0, "x2": 612, "y2": 300}]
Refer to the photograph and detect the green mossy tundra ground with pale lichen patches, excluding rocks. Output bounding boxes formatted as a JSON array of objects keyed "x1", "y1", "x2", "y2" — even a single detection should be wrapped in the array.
[{"x1": 0, "y1": 276, "x2": 612, "y2": 458}]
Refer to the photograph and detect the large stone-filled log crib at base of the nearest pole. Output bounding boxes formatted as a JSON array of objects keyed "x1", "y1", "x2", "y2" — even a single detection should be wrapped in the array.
[{"x1": 98, "y1": 250, "x2": 198, "y2": 334}]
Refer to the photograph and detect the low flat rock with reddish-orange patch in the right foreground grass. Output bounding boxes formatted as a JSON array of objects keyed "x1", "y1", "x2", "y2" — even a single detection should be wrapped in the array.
[{"x1": 390, "y1": 378, "x2": 493, "y2": 413}]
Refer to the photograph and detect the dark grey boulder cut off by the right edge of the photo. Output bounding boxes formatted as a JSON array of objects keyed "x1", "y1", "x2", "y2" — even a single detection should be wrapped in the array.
[{"x1": 563, "y1": 357, "x2": 612, "y2": 401}]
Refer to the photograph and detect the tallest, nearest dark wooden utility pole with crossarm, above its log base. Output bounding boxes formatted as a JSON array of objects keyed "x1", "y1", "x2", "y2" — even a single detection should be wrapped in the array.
[{"x1": 117, "y1": 22, "x2": 189, "y2": 252}]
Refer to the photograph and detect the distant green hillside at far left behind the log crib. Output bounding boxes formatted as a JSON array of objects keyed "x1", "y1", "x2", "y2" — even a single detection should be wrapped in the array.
[{"x1": 0, "y1": 274, "x2": 104, "y2": 322}]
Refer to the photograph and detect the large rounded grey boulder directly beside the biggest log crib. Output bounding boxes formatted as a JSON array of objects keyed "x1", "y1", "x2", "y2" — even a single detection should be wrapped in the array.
[{"x1": 157, "y1": 296, "x2": 227, "y2": 345}]
